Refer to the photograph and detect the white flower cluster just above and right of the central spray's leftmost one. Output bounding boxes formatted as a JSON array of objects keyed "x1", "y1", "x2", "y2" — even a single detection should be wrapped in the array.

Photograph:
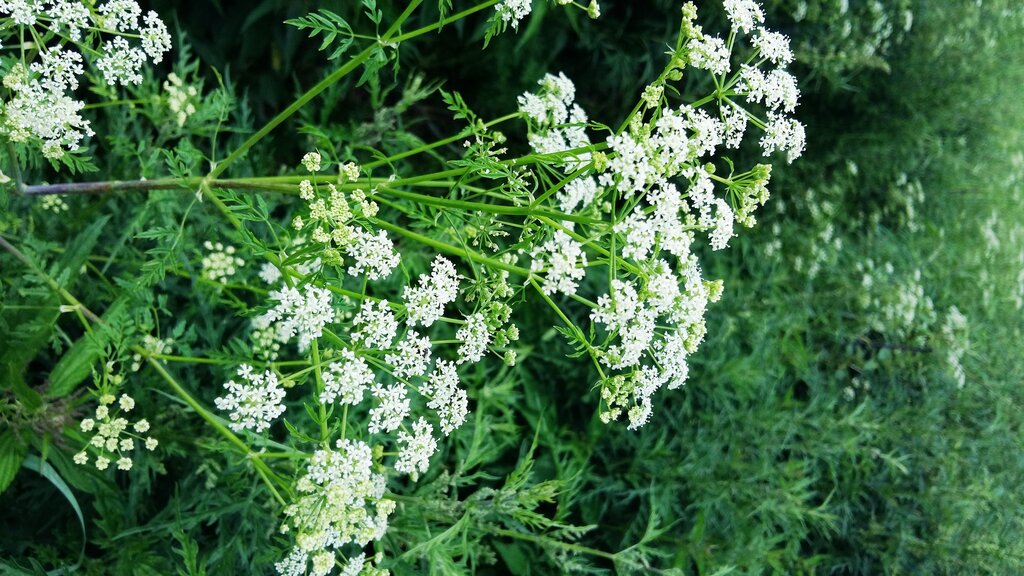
[{"x1": 257, "y1": 284, "x2": 335, "y2": 351}]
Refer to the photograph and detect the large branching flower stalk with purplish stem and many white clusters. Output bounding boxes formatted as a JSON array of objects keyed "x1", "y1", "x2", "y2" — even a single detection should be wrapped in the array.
[{"x1": 0, "y1": 0, "x2": 804, "y2": 576}]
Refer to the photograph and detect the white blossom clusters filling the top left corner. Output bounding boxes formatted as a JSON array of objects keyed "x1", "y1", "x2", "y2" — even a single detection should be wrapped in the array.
[{"x1": 0, "y1": 0, "x2": 171, "y2": 159}]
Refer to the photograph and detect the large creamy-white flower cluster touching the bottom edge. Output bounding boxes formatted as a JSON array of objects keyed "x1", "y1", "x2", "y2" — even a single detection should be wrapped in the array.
[{"x1": 275, "y1": 439, "x2": 395, "y2": 576}]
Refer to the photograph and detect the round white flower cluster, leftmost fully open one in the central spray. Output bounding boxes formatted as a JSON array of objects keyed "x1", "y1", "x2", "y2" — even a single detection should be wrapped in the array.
[{"x1": 213, "y1": 364, "x2": 285, "y2": 433}]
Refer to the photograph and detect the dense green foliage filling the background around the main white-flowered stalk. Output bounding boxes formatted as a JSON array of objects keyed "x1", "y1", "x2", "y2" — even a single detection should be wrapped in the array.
[{"x1": 0, "y1": 0, "x2": 1024, "y2": 575}]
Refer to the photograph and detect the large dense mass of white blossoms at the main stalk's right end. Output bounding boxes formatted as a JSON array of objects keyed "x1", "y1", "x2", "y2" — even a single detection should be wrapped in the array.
[{"x1": 518, "y1": 0, "x2": 804, "y2": 428}]
